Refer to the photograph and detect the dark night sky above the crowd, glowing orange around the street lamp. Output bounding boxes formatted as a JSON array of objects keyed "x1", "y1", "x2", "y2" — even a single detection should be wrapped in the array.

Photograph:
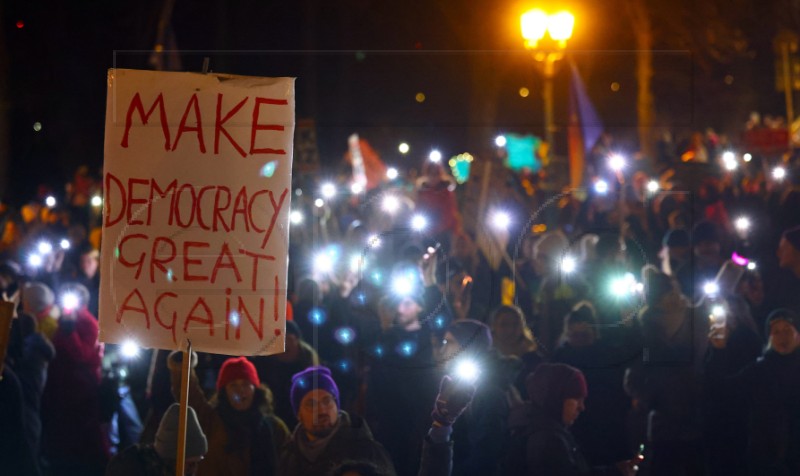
[{"x1": 0, "y1": 0, "x2": 797, "y2": 202}]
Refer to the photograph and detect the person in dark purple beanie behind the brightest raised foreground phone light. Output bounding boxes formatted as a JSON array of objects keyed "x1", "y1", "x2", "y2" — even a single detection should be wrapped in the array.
[{"x1": 437, "y1": 319, "x2": 519, "y2": 475}]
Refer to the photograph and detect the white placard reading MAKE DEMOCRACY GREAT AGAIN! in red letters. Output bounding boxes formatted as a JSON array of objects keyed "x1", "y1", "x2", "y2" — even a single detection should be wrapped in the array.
[{"x1": 100, "y1": 69, "x2": 294, "y2": 355}]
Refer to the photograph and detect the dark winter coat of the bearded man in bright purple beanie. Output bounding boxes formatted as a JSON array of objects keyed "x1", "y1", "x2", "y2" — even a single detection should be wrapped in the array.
[{"x1": 277, "y1": 412, "x2": 395, "y2": 476}]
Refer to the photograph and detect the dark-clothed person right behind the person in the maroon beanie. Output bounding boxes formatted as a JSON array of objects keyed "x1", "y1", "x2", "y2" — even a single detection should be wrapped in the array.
[{"x1": 552, "y1": 301, "x2": 633, "y2": 466}]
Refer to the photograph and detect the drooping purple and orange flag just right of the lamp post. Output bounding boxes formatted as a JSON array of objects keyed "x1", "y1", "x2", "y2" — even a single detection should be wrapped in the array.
[{"x1": 567, "y1": 61, "x2": 603, "y2": 188}]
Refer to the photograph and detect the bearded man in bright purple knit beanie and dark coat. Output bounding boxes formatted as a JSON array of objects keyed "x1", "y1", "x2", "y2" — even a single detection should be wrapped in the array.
[{"x1": 276, "y1": 366, "x2": 395, "y2": 476}]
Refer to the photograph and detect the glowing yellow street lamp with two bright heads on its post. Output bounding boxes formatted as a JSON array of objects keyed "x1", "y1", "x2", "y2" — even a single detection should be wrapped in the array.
[{"x1": 520, "y1": 8, "x2": 575, "y2": 165}]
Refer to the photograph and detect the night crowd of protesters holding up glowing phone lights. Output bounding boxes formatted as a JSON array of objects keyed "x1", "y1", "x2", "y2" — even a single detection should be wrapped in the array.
[{"x1": 0, "y1": 126, "x2": 800, "y2": 476}]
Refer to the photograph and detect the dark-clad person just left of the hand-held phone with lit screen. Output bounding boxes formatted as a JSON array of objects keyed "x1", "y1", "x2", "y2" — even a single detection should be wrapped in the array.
[{"x1": 625, "y1": 266, "x2": 709, "y2": 476}]
